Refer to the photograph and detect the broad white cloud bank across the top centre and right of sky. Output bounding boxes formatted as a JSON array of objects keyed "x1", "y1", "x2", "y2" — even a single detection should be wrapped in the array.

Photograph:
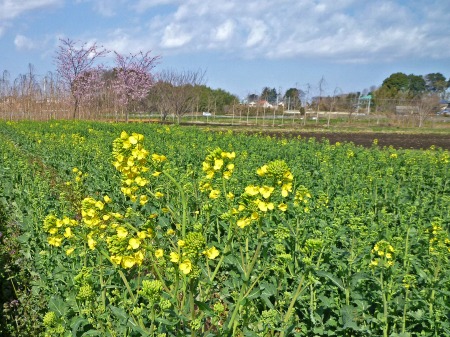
[{"x1": 97, "y1": 0, "x2": 450, "y2": 62}]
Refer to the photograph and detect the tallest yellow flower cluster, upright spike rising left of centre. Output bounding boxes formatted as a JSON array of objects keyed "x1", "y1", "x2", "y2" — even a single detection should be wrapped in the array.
[{"x1": 113, "y1": 131, "x2": 149, "y2": 201}]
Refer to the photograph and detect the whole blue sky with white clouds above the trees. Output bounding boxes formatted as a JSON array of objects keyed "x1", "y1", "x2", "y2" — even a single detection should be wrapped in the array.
[{"x1": 0, "y1": 0, "x2": 450, "y2": 97}]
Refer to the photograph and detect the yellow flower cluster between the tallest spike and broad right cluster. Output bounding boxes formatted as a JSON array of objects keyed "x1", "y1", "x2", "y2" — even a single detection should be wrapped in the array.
[{"x1": 200, "y1": 148, "x2": 236, "y2": 199}]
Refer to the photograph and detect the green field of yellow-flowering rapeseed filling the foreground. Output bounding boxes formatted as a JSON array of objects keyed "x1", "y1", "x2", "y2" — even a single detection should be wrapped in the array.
[{"x1": 0, "y1": 122, "x2": 450, "y2": 337}]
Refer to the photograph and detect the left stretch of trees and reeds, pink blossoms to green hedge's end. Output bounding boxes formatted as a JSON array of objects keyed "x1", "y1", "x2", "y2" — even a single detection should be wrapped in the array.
[{"x1": 0, "y1": 39, "x2": 238, "y2": 121}]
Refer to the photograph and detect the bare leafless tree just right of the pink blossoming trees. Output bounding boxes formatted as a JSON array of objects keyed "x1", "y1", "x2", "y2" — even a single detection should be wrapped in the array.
[{"x1": 151, "y1": 70, "x2": 205, "y2": 123}]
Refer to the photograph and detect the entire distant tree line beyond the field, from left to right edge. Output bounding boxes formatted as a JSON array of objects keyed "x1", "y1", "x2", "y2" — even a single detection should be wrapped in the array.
[{"x1": 0, "y1": 39, "x2": 450, "y2": 126}]
